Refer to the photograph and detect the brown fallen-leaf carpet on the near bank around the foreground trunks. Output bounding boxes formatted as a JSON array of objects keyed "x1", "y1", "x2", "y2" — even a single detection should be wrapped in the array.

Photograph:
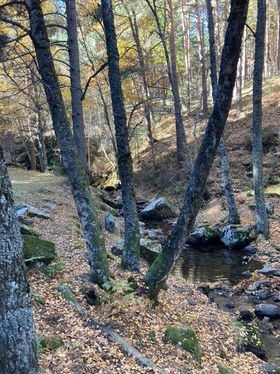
[{"x1": 10, "y1": 169, "x2": 280, "y2": 374}]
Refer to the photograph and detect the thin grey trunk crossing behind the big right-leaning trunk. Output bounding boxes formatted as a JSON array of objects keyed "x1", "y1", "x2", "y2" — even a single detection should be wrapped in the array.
[{"x1": 206, "y1": 0, "x2": 240, "y2": 224}]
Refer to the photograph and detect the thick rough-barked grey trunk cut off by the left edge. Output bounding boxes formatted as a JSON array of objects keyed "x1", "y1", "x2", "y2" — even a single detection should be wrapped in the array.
[{"x1": 0, "y1": 150, "x2": 39, "y2": 374}]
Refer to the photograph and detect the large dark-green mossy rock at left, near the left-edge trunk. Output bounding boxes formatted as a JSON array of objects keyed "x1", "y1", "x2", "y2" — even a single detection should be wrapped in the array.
[{"x1": 22, "y1": 235, "x2": 57, "y2": 265}]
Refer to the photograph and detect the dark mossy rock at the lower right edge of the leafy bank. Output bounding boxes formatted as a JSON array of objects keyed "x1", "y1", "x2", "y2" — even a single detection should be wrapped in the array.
[{"x1": 235, "y1": 322, "x2": 265, "y2": 359}]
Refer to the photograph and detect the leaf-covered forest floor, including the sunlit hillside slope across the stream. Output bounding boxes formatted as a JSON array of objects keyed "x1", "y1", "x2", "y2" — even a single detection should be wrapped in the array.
[{"x1": 9, "y1": 77, "x2": 280, "y2": 374}]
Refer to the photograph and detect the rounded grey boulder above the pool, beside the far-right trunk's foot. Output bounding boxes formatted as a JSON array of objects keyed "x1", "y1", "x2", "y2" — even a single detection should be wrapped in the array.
[{"x1": 221, "y1": 225, "x2": 251, "y2": 249}]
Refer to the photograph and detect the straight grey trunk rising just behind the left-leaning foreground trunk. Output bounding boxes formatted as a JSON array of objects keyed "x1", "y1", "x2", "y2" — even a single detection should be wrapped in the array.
[{"x1": 65, "y1": 0, "x2": 89, "y2": 175}]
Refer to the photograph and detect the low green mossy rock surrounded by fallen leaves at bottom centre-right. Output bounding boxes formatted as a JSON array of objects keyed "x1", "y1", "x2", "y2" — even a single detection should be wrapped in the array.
[{"x1": 162, "y1": 327, "x2": 201, "y2": 362}]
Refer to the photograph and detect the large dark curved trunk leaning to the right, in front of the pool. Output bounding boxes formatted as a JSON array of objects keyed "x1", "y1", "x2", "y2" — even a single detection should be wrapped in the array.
[{"x1": 145, "y1": 0, "x2": 249, "y2": 300}]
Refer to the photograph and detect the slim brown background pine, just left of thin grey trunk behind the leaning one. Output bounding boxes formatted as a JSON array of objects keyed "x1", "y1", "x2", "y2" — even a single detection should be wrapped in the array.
[{"x1": 195, "y1": 0, "x2": 208, "y2": 114}]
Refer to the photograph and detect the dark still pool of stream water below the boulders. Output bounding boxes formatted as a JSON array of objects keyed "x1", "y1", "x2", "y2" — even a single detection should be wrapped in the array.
[{"x1": 175, "y1": 247, "x2": 263, "y2": 285}]
